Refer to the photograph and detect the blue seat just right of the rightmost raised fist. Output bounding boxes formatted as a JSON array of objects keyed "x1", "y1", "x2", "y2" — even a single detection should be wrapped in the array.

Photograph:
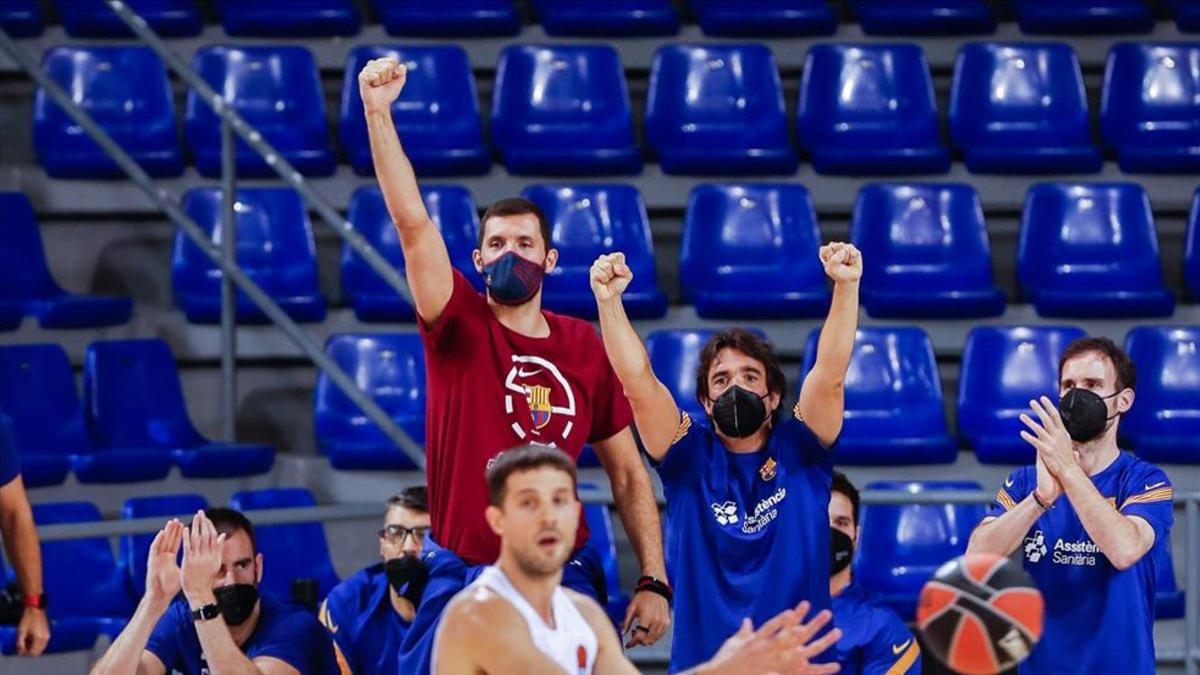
[{"x1": 850, "y1": 183, "x2": 1004, "y2": 318}]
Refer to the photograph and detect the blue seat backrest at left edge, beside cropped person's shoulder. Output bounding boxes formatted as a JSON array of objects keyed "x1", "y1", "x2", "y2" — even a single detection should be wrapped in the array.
[{"x1": 0, "y1": 343, "x2": 92, "y2": 455}]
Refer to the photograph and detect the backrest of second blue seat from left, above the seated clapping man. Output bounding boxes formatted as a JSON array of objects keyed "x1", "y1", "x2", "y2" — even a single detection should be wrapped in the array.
[{"x1": 83, "y1": 339, "x2": 208, "y2": 448}]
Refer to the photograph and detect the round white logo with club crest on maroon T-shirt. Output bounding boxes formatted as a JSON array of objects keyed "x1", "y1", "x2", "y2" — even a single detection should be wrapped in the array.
[{"x1": 504, "y1": 354, "x2": 576, "y2": 444}]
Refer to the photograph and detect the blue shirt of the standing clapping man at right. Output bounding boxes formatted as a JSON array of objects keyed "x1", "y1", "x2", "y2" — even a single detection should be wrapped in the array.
[{"x1": 988, "y1": 453, "x2": 1175, "y2": 675}]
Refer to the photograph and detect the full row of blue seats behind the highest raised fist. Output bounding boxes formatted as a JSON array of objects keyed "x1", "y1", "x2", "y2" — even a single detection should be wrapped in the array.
[{"x1": 34, "y1": 43, "x2": 1200, "y2": 178}]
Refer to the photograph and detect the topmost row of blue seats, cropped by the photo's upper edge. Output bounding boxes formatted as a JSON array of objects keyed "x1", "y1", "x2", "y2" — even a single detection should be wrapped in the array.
[{"x1": 0, "y1": 0, "x2": 1200, "y2": 37}]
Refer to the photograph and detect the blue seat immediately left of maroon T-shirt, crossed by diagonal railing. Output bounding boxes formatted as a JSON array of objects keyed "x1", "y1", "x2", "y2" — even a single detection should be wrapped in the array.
[{"x1": 313, "y1": 333, "x2": 425, "y2": 471}]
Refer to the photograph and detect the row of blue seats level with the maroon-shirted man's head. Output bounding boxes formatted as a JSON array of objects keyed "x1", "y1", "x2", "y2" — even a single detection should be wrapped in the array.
[{"x1": 0, "y1": 184, "x2": 1200, "y2": 329}]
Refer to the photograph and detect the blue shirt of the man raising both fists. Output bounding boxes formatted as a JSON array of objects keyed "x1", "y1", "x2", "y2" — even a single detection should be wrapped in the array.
[{"x1": 656, "y1": 413, "x2": 833, "y2": 673}]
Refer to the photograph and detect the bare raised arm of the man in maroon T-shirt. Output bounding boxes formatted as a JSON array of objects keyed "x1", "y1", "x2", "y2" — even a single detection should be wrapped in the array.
[{"x1": 359, "y1": 59, "x2": 454, "y2": 325}]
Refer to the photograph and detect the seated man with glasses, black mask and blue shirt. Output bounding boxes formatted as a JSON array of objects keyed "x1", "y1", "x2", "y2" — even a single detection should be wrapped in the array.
[{"x1": 320, "y1": 486, "x2": 430, "y2": 675}]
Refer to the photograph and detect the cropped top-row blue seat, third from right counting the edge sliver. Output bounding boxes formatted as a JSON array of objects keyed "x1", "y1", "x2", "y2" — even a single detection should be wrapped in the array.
[{"x1": 851, "y1": 0, "x2": 996, "y2": 35}]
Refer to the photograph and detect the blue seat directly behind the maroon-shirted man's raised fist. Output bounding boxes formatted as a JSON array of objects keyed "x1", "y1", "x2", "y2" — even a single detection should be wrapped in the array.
[{"x1": 337, "y1": 46, "x2": 491, "y2": 175}]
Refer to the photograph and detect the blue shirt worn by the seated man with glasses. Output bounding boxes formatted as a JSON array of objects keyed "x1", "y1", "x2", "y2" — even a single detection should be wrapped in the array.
[{"x1": 320, "y1": 562, "x2": 412, "y2": 673}]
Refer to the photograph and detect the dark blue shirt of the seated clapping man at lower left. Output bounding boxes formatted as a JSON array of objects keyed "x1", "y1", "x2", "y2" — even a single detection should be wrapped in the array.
[{"x1": 146, "y1": 596, "x2": 337, "y2": 675}]
